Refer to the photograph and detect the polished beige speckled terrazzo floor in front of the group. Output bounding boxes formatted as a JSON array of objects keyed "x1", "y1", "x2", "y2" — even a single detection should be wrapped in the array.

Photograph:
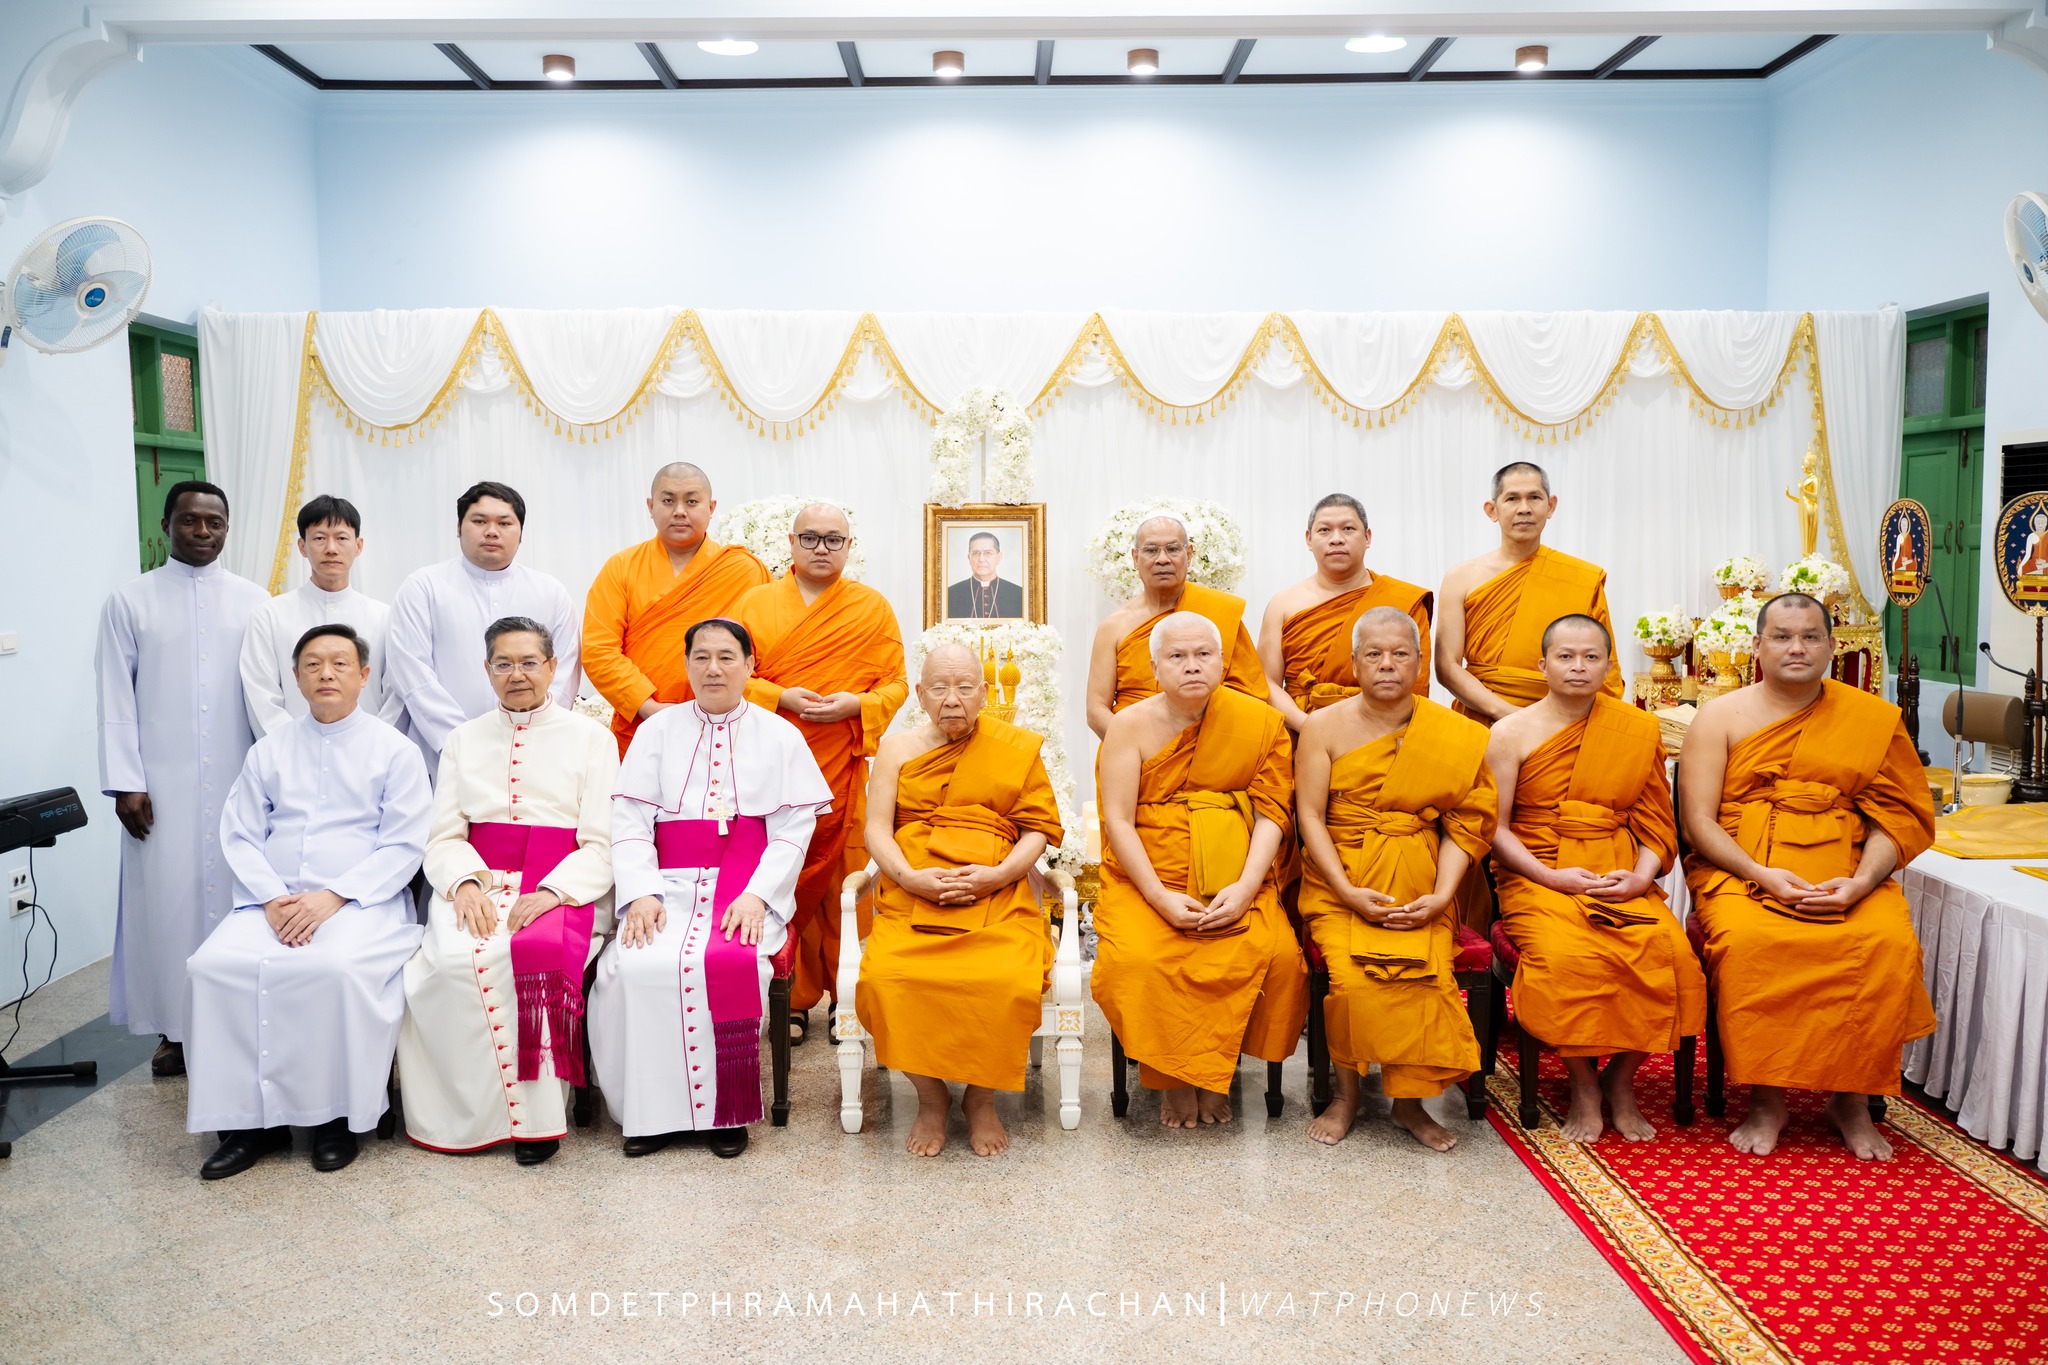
[{"x1": 0, "y1": 964, "x2": 1683, "y2": 1365}]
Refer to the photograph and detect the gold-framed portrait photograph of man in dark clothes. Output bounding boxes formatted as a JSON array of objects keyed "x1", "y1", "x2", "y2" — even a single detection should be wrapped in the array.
[{"x1": 924, "y1": 503, "x2": 1044, "y2": 626}]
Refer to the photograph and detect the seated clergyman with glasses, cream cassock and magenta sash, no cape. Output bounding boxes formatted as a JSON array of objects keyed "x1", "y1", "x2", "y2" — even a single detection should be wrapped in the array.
[{"x1": 397, "y1": 616, "x2": 618, "y2": 1166}]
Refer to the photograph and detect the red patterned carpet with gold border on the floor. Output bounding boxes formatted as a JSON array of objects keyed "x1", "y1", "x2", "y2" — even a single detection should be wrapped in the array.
[{"x1": 1489, "y1": 1029, "x2": 2048, "y2": 1365}]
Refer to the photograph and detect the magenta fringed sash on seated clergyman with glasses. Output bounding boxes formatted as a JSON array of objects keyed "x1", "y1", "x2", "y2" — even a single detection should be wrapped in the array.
[{"x1": 469, "y1": 825, "x2": 596, "y2": 1085}]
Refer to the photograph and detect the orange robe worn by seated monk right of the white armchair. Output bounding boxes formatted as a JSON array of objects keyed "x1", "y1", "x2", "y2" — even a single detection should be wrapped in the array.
[{"x1": 1092, "y1": 688, "x2": 1309, "y2": 1091}]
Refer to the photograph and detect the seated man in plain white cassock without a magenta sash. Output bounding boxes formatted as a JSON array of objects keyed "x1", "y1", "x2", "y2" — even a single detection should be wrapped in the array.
[{"x1": 184, "y1": 626, "x2": 434, "y2": 1181}]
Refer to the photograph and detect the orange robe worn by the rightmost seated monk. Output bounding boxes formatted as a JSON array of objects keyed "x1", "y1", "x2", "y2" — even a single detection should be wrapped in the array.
[{"x1": 1686, "y1": 681, "x2": 1935, "y2": 1095}]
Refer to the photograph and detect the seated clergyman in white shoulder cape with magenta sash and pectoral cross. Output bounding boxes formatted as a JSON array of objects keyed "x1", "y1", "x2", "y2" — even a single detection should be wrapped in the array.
[{"x1": 590, "y1": 618, "x2": 831, "y2": 1156}]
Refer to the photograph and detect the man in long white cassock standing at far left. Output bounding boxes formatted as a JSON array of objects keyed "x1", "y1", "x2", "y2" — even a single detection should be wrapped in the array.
[{"x1": 96, "y1": 481, "x2": 268, "y2": 1076}]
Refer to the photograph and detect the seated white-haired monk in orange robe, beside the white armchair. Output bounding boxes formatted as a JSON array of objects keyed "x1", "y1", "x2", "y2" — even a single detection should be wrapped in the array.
[{"x1": 1094, "y1": 612, "x2": 1309, "y2": 1128}]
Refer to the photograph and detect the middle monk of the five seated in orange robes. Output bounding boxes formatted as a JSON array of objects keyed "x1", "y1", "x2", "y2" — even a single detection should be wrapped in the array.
[{"x1": 1294, "y1": 606, "x2": 1497, "y2": 1152}]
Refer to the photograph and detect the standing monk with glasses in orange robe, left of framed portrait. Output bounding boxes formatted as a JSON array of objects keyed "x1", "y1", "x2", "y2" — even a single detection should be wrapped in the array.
[{"x1": 733, "y1": 503, "x2": 909, "y2": 1042}]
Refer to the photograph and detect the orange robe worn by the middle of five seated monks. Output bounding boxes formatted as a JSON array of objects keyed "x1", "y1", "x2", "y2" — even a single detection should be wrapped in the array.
[{"x1": 1300, "y1": 698, "x2": 1499, "y2": 1099}]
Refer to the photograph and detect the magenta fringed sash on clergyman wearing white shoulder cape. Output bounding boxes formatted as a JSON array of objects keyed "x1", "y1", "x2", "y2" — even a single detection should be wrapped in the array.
[{"x1": 653, "y1": 814, "x2": 768, "y2": 1128}]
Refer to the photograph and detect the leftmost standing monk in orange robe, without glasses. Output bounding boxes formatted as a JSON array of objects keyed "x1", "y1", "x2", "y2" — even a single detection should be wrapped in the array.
[{"x1": 584, "y1": 463, "x2": 768, "y2": 757}]
